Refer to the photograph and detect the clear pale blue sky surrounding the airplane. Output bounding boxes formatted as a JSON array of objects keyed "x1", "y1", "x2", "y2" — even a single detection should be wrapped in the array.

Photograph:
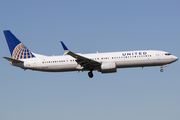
[{"x1": 0, "y1": 0, "x2": 180, "y2": 120}]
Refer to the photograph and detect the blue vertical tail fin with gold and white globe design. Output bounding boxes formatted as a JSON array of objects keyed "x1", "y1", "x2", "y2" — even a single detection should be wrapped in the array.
[{"x1": 4, "y1": 30, "x2": 35, "y2": 60}]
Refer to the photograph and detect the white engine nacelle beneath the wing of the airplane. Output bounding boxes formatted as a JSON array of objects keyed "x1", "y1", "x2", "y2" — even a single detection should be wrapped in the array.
[{"x1": 100, "y1": 62, "x2": 117, "y2": 73}]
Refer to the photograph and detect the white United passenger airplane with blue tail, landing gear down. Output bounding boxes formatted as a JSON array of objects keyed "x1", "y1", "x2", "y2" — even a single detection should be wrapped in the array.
[{"x1": 3, "y1": 30, "x2": 178, "y2": 78}]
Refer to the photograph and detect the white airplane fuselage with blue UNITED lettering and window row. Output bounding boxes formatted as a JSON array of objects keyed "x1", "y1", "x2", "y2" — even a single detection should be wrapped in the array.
[{"x1": 11, "y1": 50, "x2": 178, "y2": 72}]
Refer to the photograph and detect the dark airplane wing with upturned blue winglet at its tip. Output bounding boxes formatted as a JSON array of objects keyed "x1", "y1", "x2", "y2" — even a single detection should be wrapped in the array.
[{"x1": 61, "y1": 41, "x2": 101, "y2": 69}]
